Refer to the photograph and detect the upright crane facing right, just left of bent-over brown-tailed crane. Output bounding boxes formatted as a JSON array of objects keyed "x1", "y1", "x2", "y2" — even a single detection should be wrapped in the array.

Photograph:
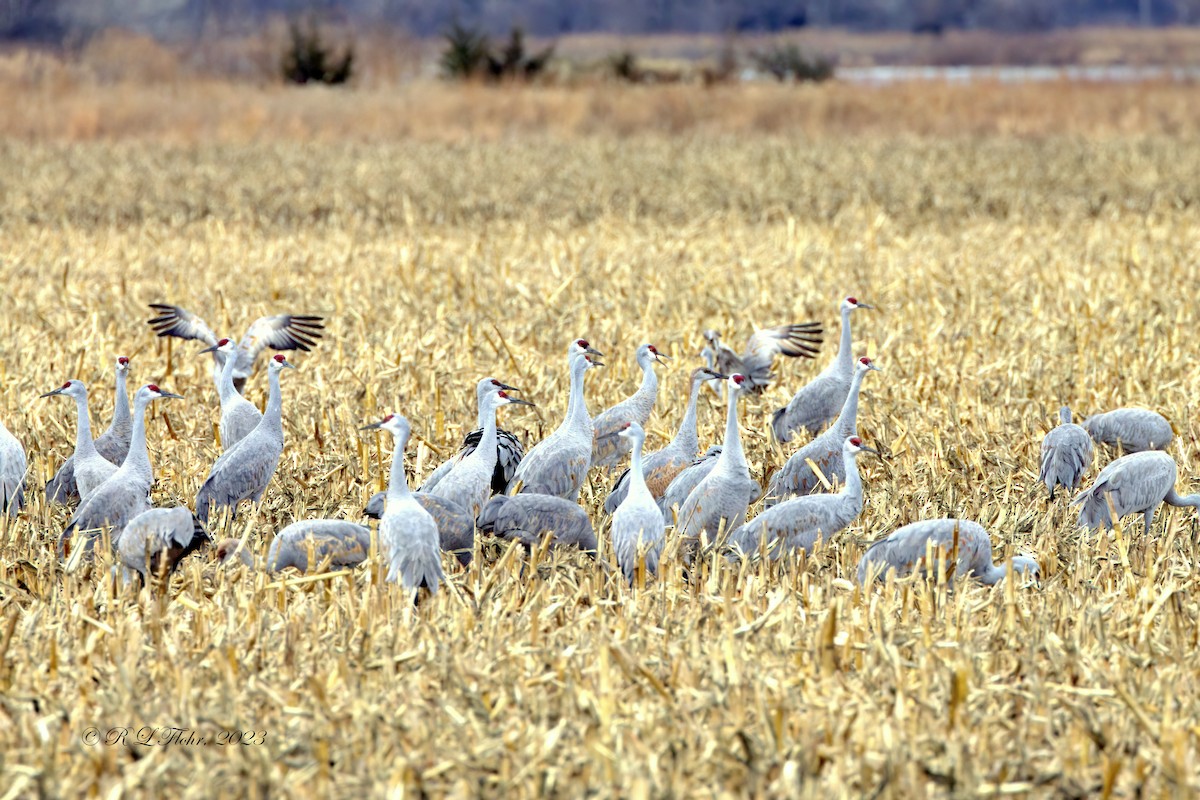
[{"x1": 59, "y1": 384, "x2": 182, "y2": 555}]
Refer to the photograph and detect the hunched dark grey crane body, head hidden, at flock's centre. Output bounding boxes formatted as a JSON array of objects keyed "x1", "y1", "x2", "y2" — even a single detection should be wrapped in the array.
[{"x1": 479, "y1": 494, "x2": 596, "y2": 554}]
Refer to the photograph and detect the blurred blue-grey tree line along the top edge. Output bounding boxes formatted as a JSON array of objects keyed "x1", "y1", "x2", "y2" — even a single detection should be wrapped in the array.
[{"x1": 0, "y1": 0, "x2": 1200, "y2": 42}]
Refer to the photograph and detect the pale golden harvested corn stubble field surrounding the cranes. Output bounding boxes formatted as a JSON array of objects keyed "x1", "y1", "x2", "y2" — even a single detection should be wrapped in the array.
[{"x1": 0, "y1": 82, "x2": 1200, "y2": 798}]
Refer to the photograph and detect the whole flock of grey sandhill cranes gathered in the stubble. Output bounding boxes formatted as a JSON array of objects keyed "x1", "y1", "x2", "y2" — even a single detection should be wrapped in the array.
[{"x1": 0, "y1": 297, "x2": 1200, "y2": 591}]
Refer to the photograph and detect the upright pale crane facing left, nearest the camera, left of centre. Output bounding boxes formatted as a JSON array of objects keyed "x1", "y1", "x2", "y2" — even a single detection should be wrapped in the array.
[{"x1": 362, "y1": 414, "x2": 445, "y2": 593}]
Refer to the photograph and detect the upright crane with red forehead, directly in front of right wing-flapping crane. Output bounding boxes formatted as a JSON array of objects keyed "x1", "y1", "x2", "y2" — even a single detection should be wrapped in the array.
[{"x1": 678, "y1": 375, "x2": 757, "y2": 565}]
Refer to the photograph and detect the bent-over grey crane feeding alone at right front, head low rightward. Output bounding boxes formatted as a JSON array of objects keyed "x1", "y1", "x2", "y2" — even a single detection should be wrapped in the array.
[{"x1": 858, "y1": 519, "x2": 1042, "y2": 585}]
